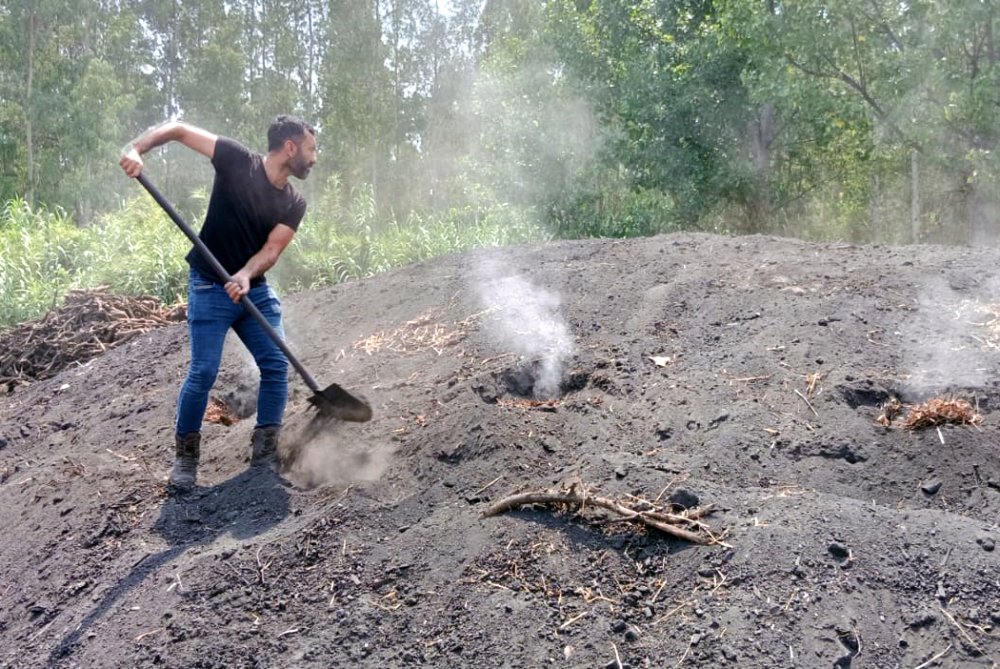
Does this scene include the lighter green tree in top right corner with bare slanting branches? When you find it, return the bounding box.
[720,0,1000,241]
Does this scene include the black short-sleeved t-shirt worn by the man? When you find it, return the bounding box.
[187,137,306,286]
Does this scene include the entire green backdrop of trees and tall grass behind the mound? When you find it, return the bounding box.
[0,0,1000,286]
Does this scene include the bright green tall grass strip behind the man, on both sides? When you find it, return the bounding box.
[0,179,545,326]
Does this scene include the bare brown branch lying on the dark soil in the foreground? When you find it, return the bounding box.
[483,485,720,545]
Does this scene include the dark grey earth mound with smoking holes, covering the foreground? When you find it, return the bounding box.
[0,235,1000,669]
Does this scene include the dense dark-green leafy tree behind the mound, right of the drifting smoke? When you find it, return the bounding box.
[548,0,767,230]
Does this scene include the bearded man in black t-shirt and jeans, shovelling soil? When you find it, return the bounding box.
[119,116,316,491]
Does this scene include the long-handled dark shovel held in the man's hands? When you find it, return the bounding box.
[136,174,372,423]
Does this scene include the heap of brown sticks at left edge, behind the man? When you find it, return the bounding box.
[0,287,184,392]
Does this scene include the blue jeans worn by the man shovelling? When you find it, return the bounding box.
[177,269,288,435]
